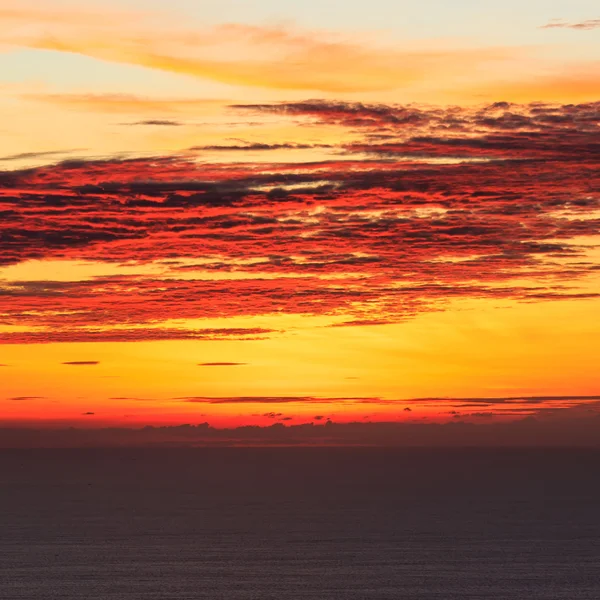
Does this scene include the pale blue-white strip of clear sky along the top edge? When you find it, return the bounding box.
[119,0,600,43]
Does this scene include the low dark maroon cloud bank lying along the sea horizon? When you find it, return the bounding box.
[0,414,600,448]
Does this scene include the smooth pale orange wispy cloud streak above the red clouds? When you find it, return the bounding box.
[0,5,576,93]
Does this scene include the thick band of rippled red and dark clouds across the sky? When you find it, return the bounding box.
[0,101,600,343]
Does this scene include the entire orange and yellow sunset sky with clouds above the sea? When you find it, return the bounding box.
[0,0,600,445]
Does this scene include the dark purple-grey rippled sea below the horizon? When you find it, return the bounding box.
[0,448,600,600]
